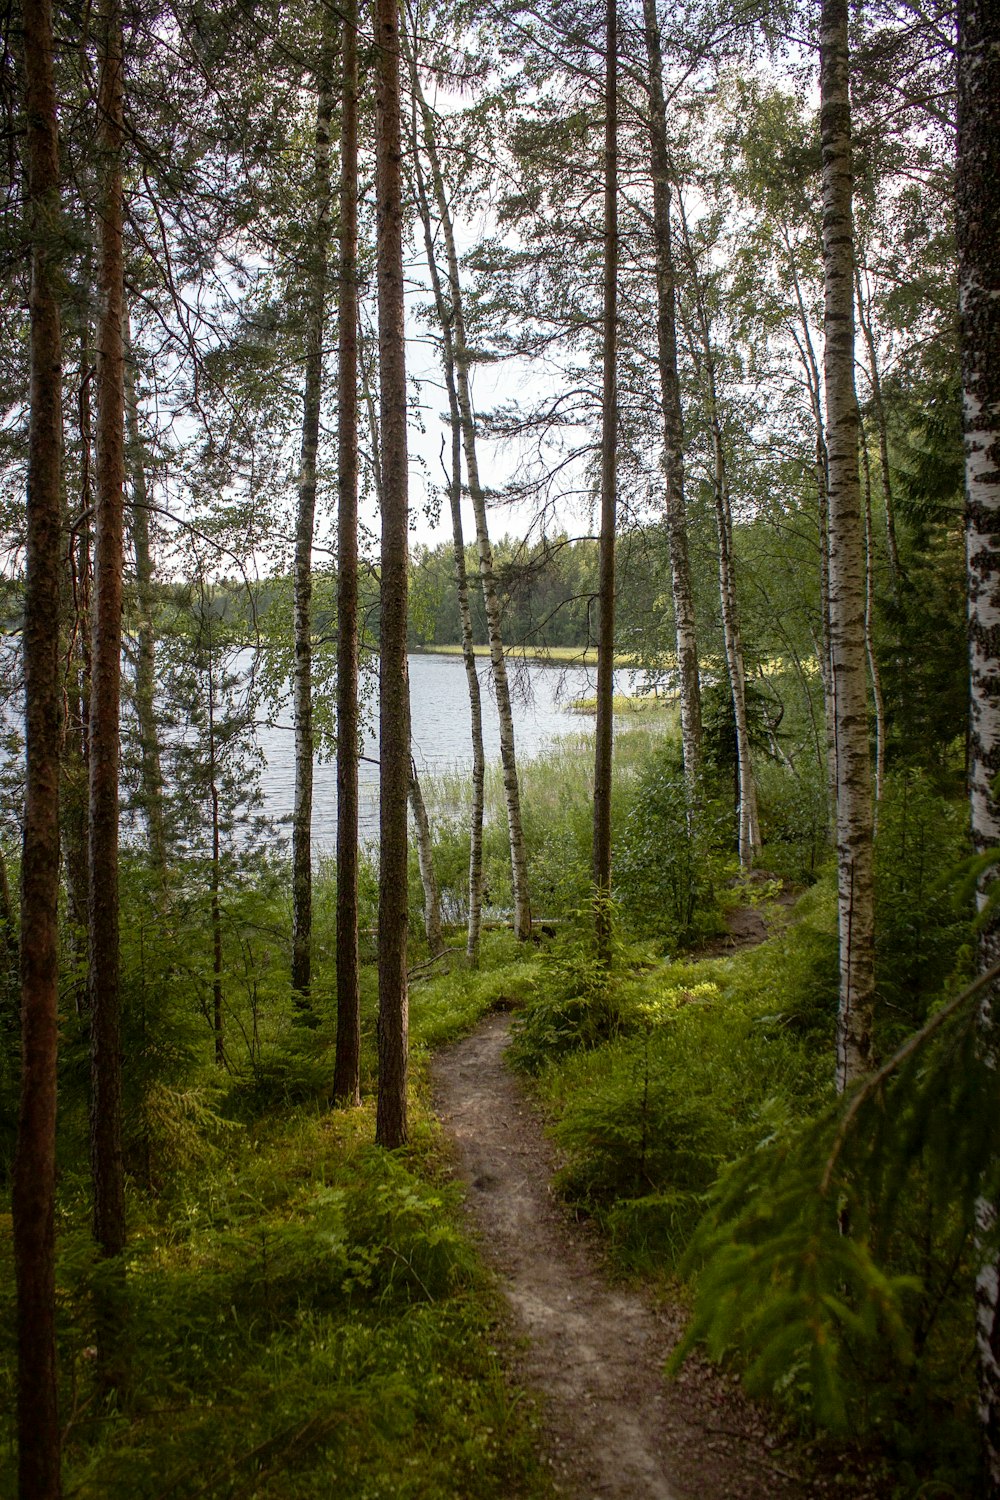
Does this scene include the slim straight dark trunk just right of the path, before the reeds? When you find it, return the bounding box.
[594,0,618,963]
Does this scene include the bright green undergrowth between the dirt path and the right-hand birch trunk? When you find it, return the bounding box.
[511,887,837,1275]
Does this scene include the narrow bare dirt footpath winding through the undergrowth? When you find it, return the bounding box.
[432,908,886,1500]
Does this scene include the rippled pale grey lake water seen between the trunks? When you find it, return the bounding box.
[259,653,634,855]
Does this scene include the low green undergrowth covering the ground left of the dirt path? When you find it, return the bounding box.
[0,945,547,1500]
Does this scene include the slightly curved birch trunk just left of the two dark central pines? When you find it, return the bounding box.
[292,3,333,1011]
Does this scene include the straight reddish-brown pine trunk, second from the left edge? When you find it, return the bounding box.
[88,0,124,1386]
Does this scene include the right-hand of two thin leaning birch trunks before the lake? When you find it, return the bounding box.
[411,57,531,941]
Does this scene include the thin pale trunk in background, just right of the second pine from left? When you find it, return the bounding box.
[124,315,166,885]
